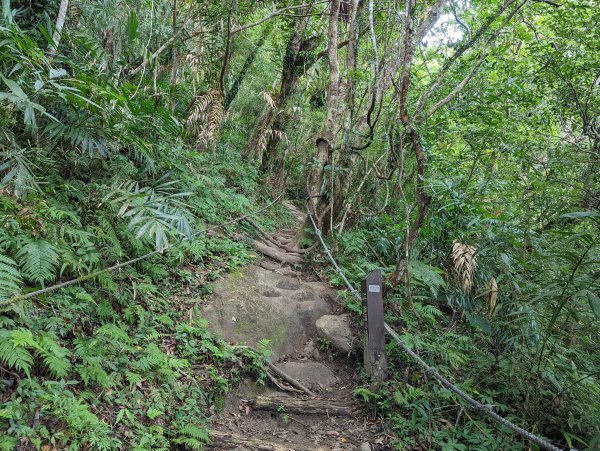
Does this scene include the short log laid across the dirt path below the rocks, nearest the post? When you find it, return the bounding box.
[250,396,358,417]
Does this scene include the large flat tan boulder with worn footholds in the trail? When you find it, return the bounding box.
[201,265,335,361]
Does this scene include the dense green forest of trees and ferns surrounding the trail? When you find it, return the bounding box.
[0,0,600,450]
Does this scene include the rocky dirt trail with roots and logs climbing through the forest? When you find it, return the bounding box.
[202,205,386,451]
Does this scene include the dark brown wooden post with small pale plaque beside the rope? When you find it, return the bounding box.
[362,269,388,382]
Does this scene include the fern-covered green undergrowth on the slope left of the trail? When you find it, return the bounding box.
[0,20,287,450]
